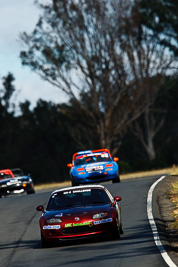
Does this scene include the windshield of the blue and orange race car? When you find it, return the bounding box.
[75,152,111,165]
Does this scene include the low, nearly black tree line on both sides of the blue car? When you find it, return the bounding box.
[0,74,178,183]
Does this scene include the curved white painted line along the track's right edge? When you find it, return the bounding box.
[147,176,177,267]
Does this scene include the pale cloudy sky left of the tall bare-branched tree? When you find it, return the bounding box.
[0,0,67,111]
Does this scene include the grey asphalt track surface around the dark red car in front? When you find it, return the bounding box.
[0,176,171,267]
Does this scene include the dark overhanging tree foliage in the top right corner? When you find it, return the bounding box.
[139,0,178,57]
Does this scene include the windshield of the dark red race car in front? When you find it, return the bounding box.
[47,189,110,210]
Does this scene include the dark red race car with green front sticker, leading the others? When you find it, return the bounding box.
[36,185,123,247]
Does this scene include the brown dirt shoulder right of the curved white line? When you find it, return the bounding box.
[155,175,178,265]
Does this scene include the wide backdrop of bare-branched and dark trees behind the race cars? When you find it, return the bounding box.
[0,0,178,184]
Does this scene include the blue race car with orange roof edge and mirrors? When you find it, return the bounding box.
[67,149,120,186]
